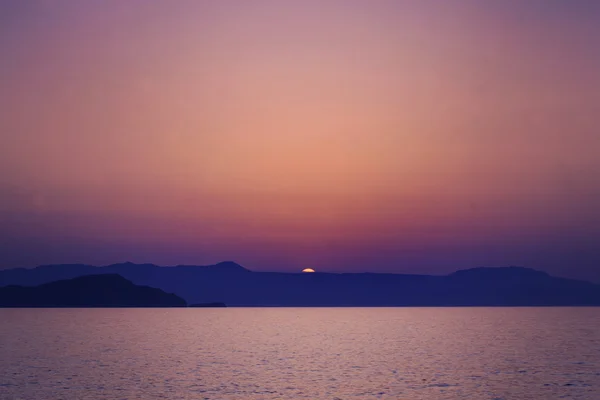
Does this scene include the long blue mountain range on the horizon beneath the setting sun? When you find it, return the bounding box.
[0,262,600,307]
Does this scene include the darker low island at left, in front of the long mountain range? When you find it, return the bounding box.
[0,274,187,307]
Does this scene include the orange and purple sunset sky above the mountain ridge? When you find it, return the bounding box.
[0,0,600,282]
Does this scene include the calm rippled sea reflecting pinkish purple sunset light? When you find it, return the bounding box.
[0,308,600,400]
